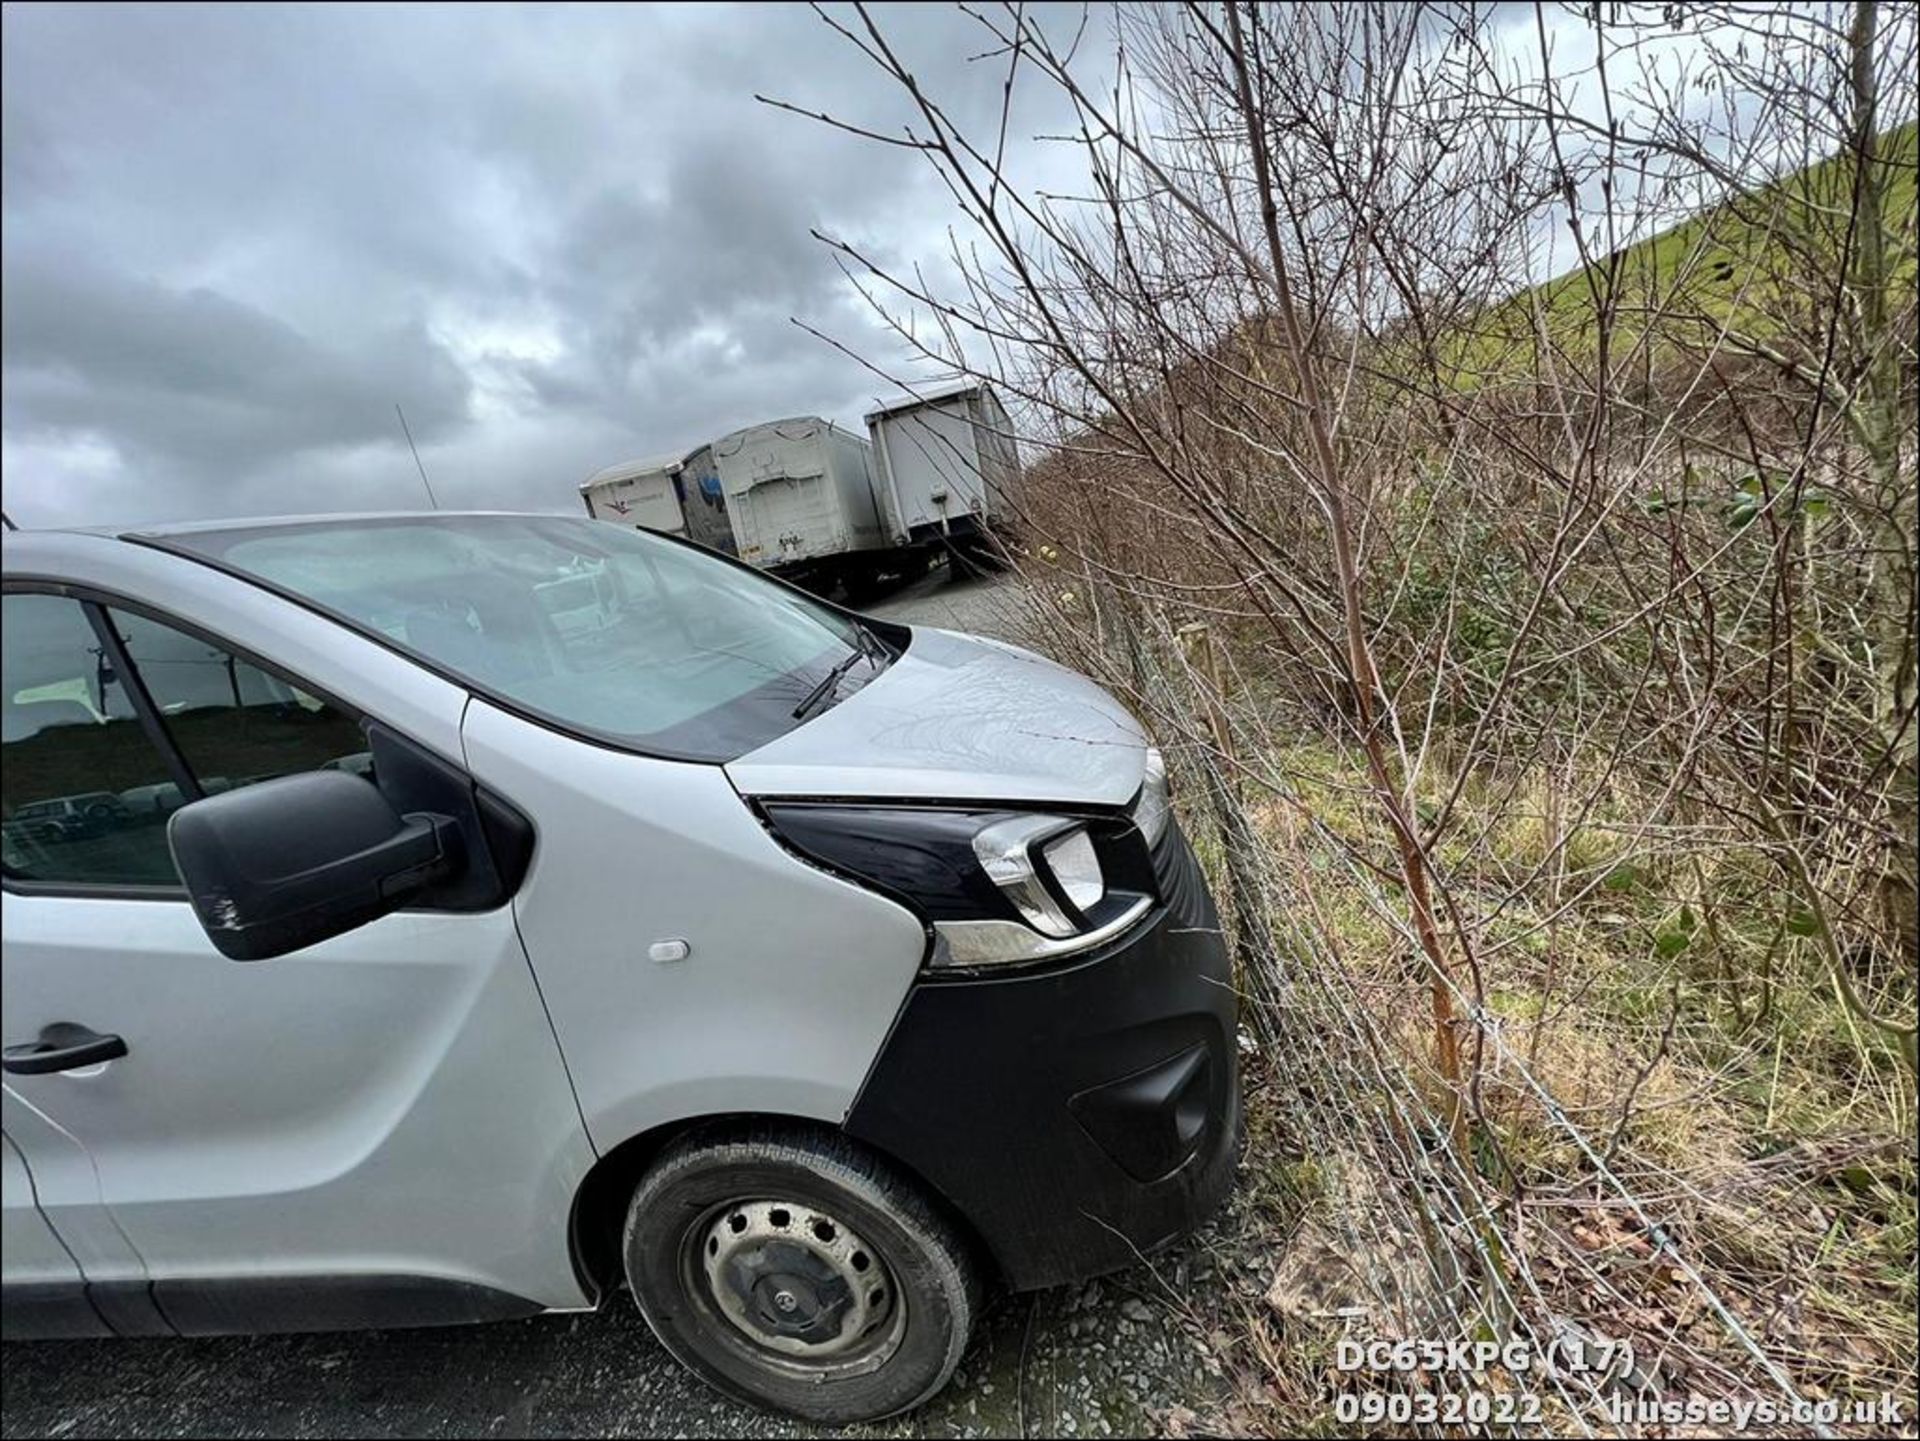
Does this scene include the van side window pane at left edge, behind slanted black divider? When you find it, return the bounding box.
[0,595,180,885]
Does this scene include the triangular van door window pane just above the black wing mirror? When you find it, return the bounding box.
[108,608,372,794]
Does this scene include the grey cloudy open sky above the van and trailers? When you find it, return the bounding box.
[0,4,1098,526]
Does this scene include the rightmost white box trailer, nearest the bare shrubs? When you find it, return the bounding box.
[866,382,1020,575]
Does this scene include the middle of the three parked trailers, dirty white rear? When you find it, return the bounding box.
[712,414,889,589]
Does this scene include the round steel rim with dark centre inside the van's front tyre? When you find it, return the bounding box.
[701,1201,897,1362]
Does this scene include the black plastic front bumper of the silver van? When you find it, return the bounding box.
[847,827,1240,1289]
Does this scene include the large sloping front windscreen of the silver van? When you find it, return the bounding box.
[153,514,889,762]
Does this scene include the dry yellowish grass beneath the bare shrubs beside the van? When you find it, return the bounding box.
[1037,598,1920,1435]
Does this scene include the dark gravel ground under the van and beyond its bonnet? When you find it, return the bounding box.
[0,570,1244,1437]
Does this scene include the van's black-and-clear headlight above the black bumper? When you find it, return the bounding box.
[764,804,1154,969]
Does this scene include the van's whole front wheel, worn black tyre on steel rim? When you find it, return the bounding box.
[624,1124,979,1424]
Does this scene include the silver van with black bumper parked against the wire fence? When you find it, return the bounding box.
[0,512,1240,1422]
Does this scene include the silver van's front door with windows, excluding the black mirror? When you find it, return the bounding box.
[0,591,591,1334]
